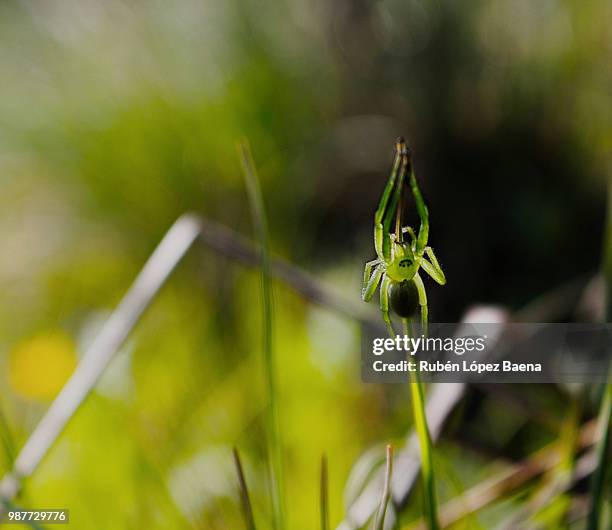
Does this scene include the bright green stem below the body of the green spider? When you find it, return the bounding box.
[402,318,440,530]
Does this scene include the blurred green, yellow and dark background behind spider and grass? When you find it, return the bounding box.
[0,0,612,530]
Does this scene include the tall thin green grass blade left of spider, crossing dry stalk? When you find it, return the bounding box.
[239,141,286,530]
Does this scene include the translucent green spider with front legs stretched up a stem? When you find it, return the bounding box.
[361,137,446,336]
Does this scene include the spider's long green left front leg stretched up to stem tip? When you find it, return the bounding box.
[374,139,408,259]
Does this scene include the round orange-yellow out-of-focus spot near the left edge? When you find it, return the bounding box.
[9,332,76,401]
